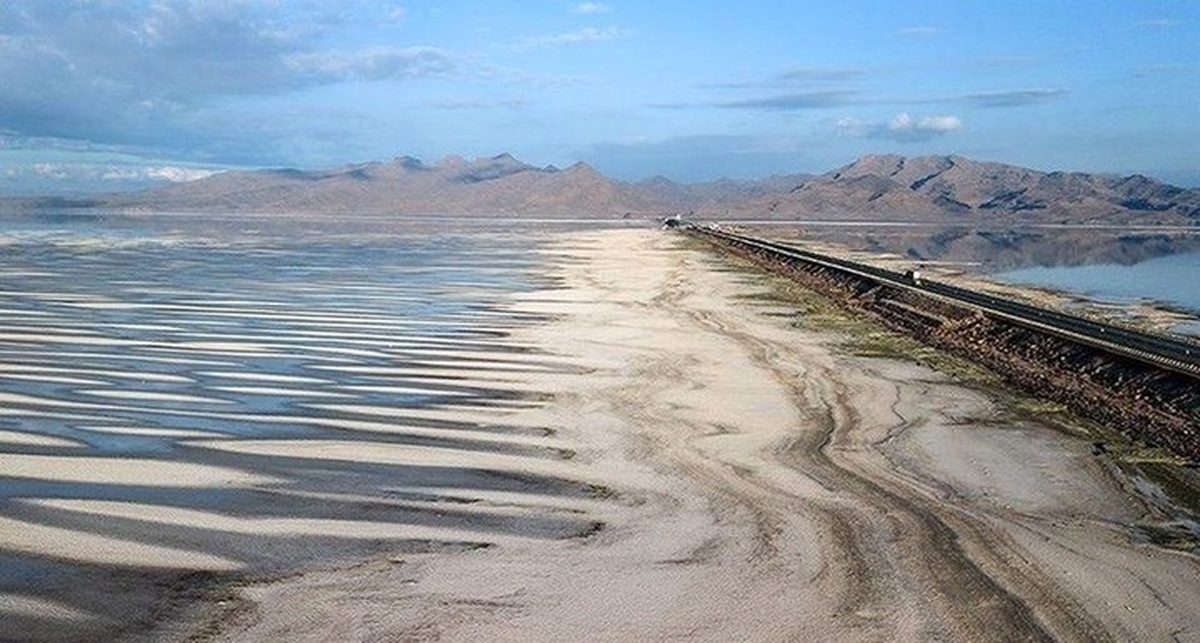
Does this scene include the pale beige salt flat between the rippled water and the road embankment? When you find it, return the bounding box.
[204,230,1200,641]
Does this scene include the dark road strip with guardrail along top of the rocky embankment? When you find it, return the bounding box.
[686,222,1200,379]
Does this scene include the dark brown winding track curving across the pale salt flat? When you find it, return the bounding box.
[654,238,1106,641]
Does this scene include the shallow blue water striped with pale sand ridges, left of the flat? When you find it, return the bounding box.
[0,216,604,638]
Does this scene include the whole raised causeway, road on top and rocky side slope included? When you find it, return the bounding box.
[678,223,1200,462]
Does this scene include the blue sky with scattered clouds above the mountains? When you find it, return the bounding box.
[0,0,1200,196]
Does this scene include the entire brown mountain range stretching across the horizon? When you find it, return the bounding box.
[8,154,1200,226]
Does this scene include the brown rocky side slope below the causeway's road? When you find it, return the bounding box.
[700,235,1200,463]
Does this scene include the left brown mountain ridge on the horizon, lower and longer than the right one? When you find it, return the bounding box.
[79,154,808,217]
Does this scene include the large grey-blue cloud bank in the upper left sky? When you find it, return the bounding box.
[0,0,456,162]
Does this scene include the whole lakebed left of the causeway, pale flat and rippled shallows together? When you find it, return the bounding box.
[0,223,1200,641]
